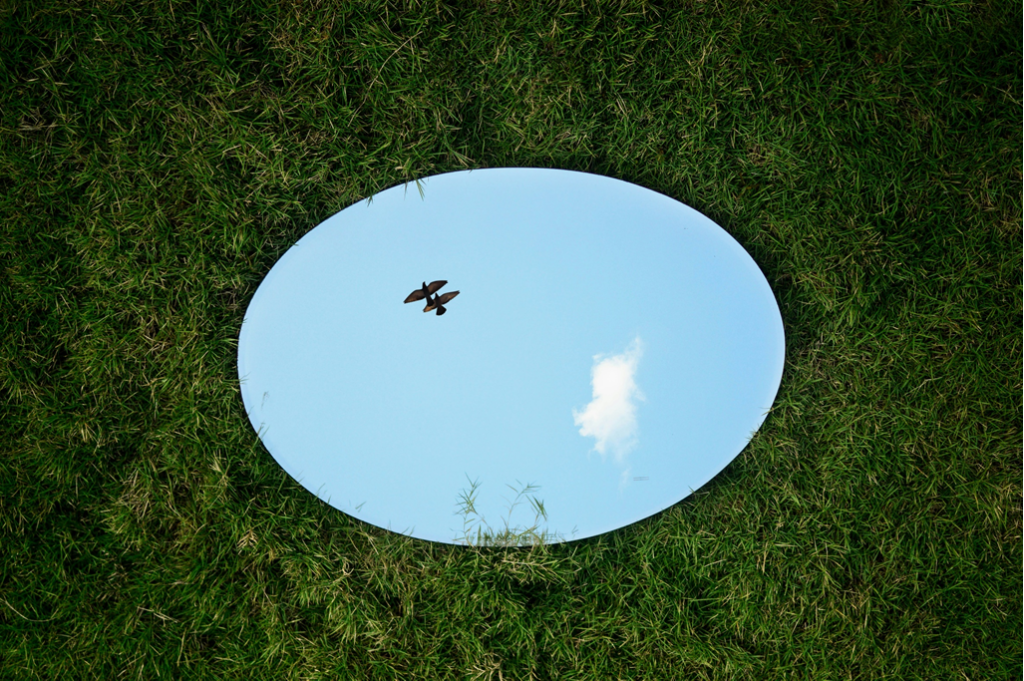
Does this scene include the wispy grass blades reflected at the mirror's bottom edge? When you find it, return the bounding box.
[454,476,562,546]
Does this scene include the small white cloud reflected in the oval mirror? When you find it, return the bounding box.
[572,336,644,463]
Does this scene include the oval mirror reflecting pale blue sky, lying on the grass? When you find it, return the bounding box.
[239,168,784,544]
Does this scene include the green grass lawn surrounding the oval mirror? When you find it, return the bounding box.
[0,0,1024,680]
